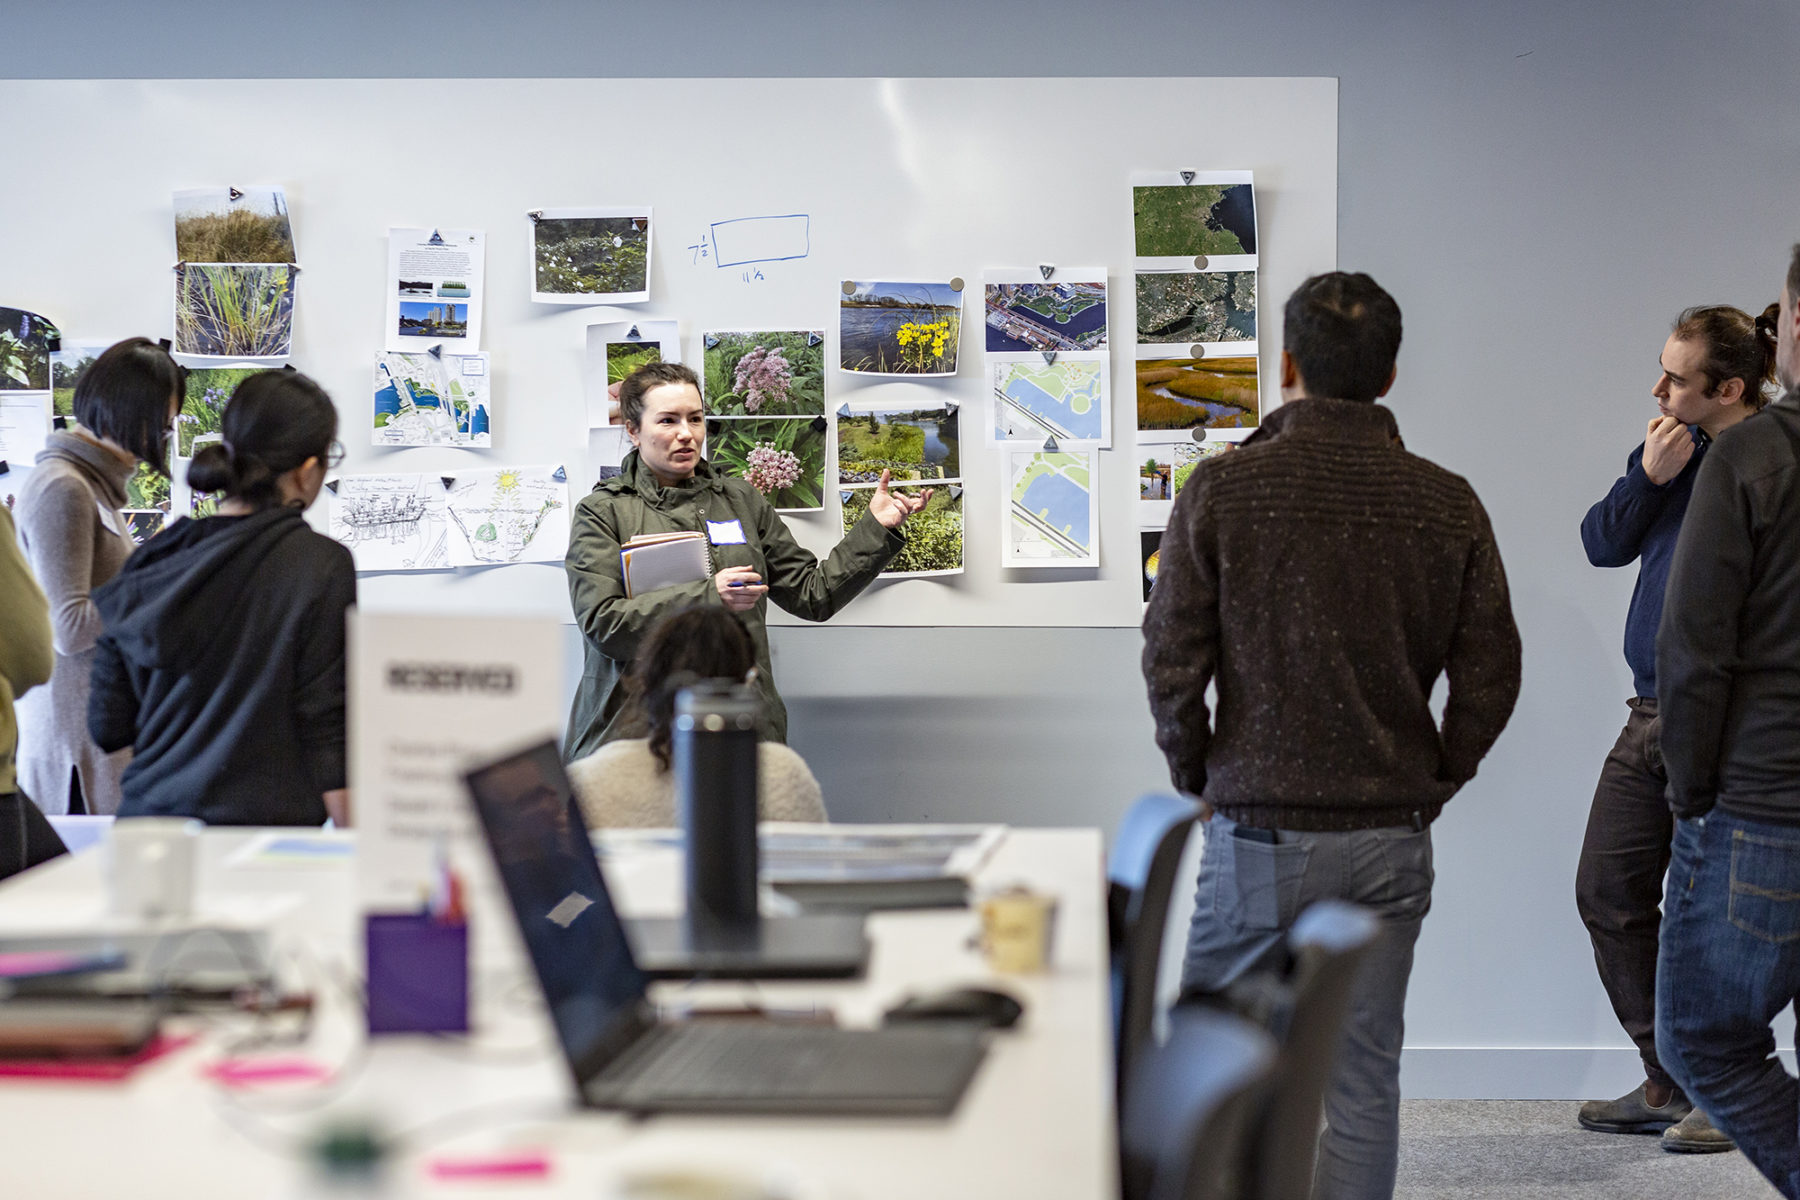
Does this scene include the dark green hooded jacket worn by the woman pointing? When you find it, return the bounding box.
[563,450,905,759]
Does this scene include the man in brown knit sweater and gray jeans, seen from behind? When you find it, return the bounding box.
[1143,272,1519,1200]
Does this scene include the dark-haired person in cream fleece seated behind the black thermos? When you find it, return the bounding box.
[569,604,824,826]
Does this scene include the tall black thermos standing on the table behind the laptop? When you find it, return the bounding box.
[675,680,761,932]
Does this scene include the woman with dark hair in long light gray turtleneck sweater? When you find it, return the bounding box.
[18,338,187,813]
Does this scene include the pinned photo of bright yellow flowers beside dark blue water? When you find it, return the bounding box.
[837,281,963,374]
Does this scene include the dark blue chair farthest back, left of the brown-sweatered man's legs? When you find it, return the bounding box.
[1107,793,1201,1097]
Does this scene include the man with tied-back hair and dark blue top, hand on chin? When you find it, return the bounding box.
[1575,304,1775,1153]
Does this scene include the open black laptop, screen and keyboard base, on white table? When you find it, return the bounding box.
[464,741,986,1115]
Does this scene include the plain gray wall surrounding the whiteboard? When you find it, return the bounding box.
[14,0,1800,1094]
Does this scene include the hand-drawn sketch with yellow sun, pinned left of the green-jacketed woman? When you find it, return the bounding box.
[446,466,569,567]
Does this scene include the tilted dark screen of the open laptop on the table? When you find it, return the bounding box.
[464,741,646,1085]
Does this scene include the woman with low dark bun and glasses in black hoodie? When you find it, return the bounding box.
[88,371,356,826]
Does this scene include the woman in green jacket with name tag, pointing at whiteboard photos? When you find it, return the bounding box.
[563,363,931,759]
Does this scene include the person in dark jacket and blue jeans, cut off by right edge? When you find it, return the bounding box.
[1656,245,1800,1200]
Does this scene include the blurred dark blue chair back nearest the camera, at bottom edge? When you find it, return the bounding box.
[1120,1007,1280,1200]
